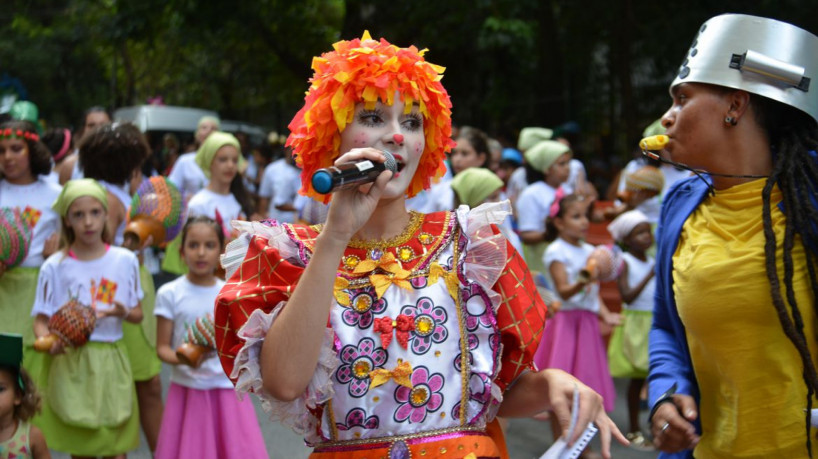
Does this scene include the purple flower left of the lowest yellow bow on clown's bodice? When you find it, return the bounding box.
[335,338,389,398]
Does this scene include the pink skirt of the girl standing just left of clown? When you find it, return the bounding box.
[154,383,270,459]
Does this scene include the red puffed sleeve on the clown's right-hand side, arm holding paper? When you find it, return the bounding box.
[494,237,547,391]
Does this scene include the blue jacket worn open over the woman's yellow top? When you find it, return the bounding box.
[648,177,708,459]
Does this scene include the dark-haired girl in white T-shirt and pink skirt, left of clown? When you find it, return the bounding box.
[154,217,269,459]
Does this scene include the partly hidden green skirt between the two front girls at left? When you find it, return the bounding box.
[122,266,162,381]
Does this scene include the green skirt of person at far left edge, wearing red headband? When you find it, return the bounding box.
[0,267,40,346]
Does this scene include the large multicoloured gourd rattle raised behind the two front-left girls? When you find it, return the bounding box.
[125,176,187,247]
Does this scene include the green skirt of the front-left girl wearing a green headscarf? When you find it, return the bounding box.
[33,341,139,456]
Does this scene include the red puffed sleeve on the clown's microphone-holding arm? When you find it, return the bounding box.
[214,236,304,383]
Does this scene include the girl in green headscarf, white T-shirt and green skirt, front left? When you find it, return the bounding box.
[32,179,142,457]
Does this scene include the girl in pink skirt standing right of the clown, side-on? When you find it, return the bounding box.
[534,194,622,456]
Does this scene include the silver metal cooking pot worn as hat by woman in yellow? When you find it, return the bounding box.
[670,14,818,121]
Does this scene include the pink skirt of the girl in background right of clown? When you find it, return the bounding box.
[534,310,616,412]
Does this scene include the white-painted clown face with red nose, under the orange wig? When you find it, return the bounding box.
[340,94,426,199]
